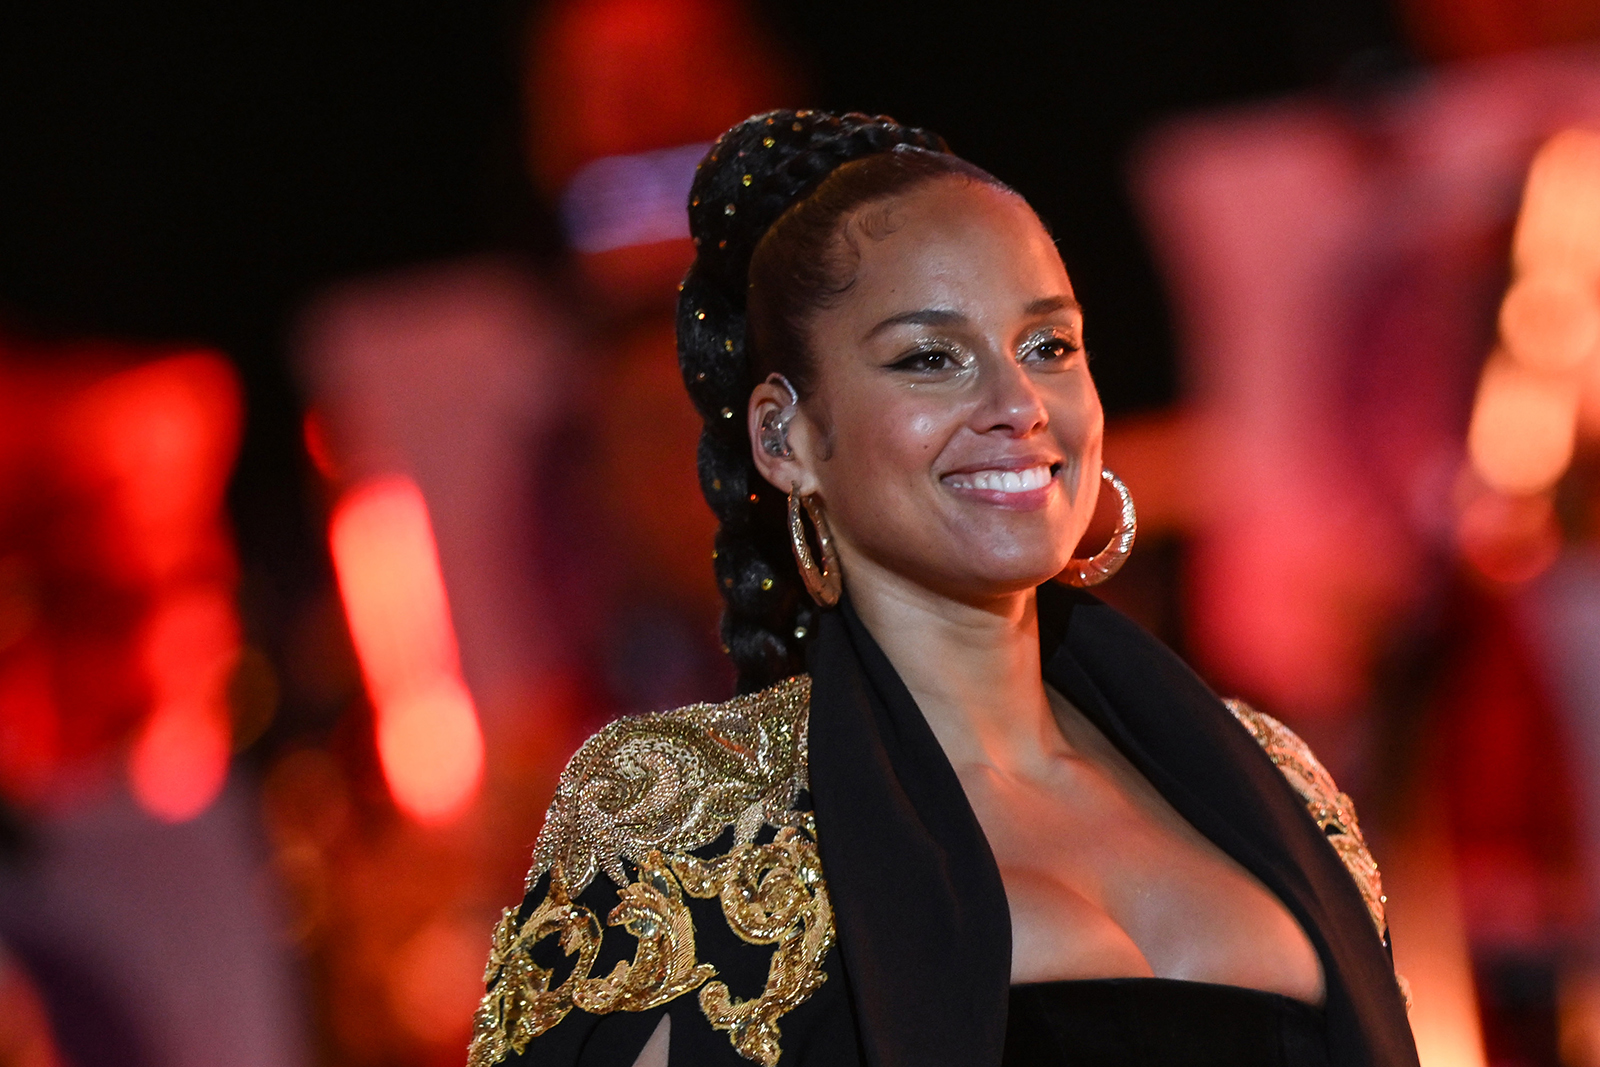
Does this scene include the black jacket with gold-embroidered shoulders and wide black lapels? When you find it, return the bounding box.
[470,584,1418,1067]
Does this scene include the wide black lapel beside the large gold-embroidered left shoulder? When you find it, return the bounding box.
[806,600,1011,1067]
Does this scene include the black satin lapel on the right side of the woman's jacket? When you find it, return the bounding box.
[1038,584,1418,1067]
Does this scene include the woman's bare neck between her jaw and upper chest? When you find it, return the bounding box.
[846,560,1066,771]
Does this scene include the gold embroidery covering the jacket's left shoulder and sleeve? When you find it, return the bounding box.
[467,675,834,1067]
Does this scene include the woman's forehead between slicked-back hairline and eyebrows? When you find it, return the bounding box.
[835,176,1072,327]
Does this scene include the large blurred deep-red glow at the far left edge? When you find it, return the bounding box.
[0,338,243,821]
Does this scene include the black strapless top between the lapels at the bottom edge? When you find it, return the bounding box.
[1002,977,1328,1067]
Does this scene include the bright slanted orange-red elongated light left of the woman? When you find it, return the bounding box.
[330,475,483,822]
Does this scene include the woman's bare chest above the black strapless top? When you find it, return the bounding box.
[962,745,1322,1001]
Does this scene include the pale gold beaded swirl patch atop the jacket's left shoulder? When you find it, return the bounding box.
[528,675,811,894]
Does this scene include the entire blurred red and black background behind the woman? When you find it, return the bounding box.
[0,0,1600,1067]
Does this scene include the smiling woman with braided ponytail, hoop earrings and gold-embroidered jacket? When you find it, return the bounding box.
[472,112,1416,1067]
